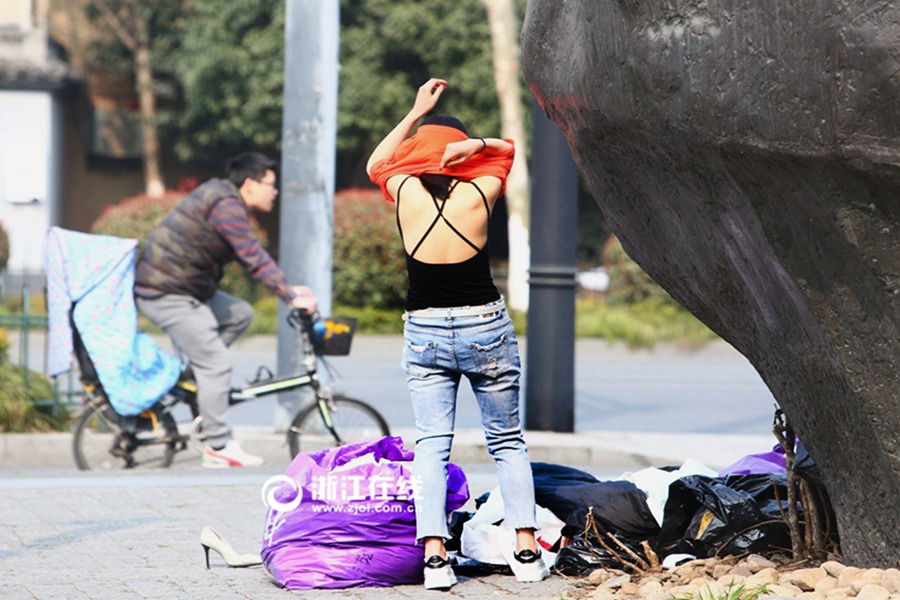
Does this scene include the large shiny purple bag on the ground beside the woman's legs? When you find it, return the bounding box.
[262,437,469,589]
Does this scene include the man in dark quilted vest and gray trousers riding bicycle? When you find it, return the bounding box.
[134,152,317,468]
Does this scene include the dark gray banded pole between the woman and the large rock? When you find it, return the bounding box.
[525,101,578,432]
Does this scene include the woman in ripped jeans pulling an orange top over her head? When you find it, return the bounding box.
[366,79,549,589]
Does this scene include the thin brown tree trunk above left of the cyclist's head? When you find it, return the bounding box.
[134,11,166,198]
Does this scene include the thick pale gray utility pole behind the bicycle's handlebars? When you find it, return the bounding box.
[275,0,340,431]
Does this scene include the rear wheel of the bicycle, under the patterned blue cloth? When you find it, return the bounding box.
[72,398,180,471]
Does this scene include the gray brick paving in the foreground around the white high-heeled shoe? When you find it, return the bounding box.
[0,467,581,600]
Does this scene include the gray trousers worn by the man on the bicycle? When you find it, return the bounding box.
[135,292,253,444]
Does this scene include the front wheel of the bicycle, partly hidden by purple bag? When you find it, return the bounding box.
[288,394,391,458]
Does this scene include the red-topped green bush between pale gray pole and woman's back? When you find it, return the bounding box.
[332,188,407,309]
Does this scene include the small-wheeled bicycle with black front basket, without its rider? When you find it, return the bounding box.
[72,309,390,470]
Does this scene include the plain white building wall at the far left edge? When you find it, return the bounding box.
[0,90,61,273]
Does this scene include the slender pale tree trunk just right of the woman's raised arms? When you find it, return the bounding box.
[482,0,531,312]
